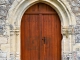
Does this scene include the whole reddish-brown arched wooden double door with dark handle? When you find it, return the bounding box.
[21,3,62,60]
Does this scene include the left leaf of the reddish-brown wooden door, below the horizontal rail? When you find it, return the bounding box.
[22,15,40,60]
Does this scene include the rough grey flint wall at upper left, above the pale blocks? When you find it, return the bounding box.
[0,0,14,35]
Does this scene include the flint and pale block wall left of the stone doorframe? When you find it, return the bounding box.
[0,0,14,60]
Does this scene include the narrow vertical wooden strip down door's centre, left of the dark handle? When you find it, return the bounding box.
[39,14,45,60]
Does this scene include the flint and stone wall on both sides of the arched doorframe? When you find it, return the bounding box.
[0,0,80,60]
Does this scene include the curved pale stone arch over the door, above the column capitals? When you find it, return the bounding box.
[7,0,76,28]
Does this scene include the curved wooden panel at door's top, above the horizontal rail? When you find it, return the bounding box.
[24,2,57,14]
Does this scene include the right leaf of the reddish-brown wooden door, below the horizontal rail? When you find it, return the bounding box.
[42,15,61,60]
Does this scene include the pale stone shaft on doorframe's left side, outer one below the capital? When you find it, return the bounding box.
[10,30,16,60]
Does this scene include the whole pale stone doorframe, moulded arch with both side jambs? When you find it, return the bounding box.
[6,0,76,60]
